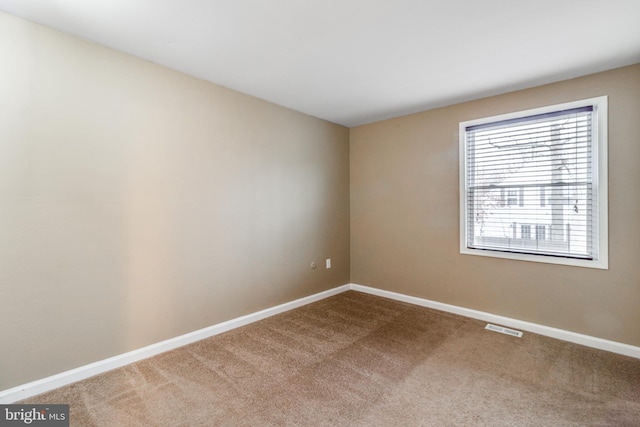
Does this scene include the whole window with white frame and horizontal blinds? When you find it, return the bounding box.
[460,97,608,269]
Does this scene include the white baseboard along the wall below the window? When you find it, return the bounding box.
[349,283,640,359]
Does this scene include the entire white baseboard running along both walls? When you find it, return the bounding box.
[0,283,640,404]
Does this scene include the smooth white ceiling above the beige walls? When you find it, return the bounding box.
[0,0,640,126]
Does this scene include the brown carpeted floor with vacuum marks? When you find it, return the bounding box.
[24,291,640,426]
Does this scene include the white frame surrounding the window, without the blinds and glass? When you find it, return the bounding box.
[459,96,609,269]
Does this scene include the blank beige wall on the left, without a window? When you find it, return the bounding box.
[0,13,349,390]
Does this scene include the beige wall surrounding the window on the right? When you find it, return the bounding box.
[350,65,640,346]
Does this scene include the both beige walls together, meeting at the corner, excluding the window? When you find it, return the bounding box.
[0,7,640,390]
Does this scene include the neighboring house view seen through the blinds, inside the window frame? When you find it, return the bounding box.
[468,108,595,257]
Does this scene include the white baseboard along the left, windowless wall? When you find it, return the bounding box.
[0,284,350,404]
